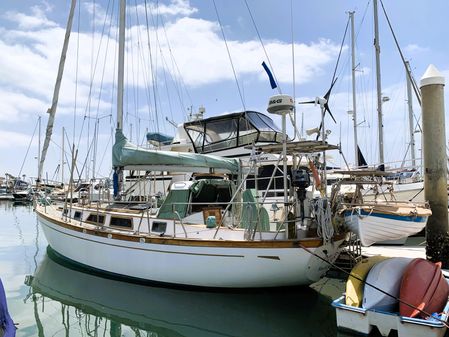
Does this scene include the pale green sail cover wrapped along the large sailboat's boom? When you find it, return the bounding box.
[112,130,240,173]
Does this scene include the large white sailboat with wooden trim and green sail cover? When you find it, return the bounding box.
[36,0,346,288]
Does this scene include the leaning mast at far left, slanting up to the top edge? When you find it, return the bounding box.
[37,0,76,181]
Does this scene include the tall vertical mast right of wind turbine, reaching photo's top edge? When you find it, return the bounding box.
[373,0,385,165]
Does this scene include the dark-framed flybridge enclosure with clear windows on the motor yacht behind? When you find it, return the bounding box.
[184,111,282,153]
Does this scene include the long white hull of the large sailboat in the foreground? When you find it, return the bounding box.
[37,210,343,288]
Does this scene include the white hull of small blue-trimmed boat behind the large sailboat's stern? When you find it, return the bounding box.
[345,212,427,247]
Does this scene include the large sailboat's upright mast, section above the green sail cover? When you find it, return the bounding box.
[117,0,126,131]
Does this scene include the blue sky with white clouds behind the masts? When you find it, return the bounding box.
[0,0,449,184]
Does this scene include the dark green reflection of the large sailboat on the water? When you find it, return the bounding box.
[25,248,337,337]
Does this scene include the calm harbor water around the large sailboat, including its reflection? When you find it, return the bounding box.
[0,202,380,337]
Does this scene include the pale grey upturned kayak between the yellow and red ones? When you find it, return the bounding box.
[362,257,413,312]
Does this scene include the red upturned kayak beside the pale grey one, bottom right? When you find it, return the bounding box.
[399,259,449,318]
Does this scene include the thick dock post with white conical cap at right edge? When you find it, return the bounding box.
[420,65,449,268]
